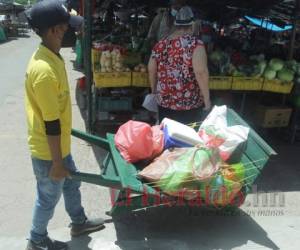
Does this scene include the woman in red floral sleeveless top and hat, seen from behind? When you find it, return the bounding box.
[148,6,211,124]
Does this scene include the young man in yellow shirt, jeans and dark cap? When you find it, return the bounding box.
[25,0,104,250]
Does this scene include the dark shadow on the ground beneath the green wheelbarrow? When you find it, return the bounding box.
[113,207,279,250]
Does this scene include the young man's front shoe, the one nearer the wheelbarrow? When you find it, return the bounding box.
[71,219,105,237]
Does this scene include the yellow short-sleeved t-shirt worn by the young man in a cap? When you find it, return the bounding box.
[25,45,72,160]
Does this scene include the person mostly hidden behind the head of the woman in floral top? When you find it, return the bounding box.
[147,0,186,49]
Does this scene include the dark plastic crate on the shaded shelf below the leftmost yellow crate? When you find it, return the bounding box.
[97,96,132,112]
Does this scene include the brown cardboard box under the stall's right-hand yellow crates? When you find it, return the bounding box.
[255,105,292,128]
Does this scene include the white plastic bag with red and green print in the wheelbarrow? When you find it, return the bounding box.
[198,106,249,161]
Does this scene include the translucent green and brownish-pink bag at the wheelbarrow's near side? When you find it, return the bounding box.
[139,147,221,199]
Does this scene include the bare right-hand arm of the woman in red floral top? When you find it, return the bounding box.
[193,46,211,110]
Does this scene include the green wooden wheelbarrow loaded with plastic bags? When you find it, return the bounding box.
[72,109,276,216]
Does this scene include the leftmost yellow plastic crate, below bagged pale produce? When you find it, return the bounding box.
[94,72,131,88]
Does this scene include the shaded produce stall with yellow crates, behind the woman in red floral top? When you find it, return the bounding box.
[82,1,300,141]
